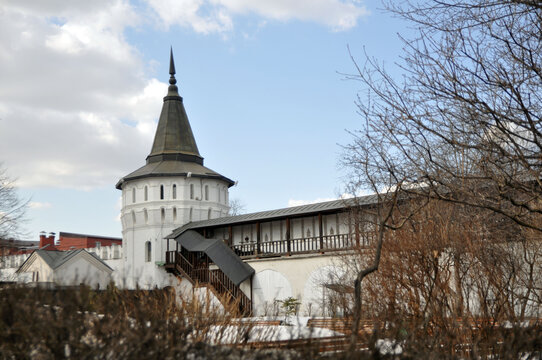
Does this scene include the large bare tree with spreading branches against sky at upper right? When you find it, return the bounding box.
[346,0,542,230]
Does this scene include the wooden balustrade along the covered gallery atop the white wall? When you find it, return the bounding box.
[231,234,356,257]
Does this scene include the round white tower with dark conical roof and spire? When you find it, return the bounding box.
[116,52,234,288]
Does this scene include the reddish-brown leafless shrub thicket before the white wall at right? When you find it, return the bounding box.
[345,201,542,358]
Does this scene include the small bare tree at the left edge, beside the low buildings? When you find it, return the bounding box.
[0,165,28,239]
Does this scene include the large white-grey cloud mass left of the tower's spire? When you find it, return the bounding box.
[0,0,159,190]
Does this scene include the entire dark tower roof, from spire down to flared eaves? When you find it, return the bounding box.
[116,51,234,189]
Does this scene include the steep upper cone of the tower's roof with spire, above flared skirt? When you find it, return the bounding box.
[147,51,203,162]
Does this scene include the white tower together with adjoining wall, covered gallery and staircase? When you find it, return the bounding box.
[116,50,375,315]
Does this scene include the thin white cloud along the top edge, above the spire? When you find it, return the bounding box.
[146,0,368,34]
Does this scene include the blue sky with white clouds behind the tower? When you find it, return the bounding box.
[0,0,406,240]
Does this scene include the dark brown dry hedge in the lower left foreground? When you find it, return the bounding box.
[0,286,302,359]
